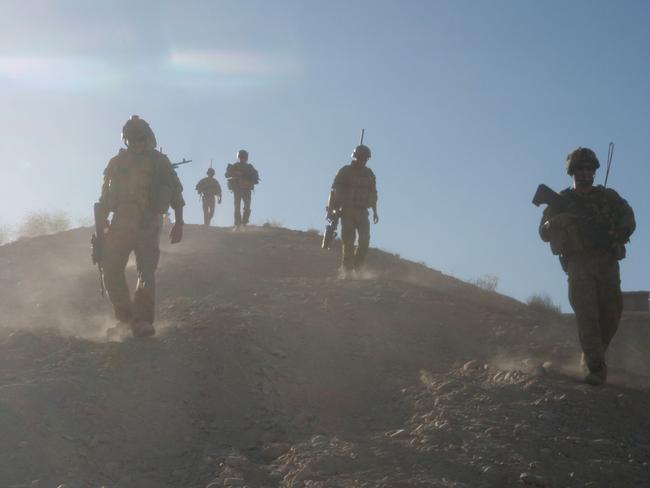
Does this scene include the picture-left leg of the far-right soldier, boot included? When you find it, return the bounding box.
[569,263,605,372]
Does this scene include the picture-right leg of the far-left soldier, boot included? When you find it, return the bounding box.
[133,226,160,335]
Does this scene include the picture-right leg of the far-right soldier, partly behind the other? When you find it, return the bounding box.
[598,261,623,351]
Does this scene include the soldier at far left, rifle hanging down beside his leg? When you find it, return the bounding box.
[95,115,185,337]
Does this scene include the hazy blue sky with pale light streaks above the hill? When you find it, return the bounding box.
[0,0,650,309]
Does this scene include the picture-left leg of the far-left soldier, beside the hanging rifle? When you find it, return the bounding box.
[102,228,133,323]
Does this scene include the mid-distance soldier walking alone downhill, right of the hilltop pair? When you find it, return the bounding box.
[327,145,379,276]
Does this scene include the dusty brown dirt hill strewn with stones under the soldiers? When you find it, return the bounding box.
[0,226,650,488]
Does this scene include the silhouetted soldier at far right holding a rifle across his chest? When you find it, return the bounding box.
[539,147,636,385]
